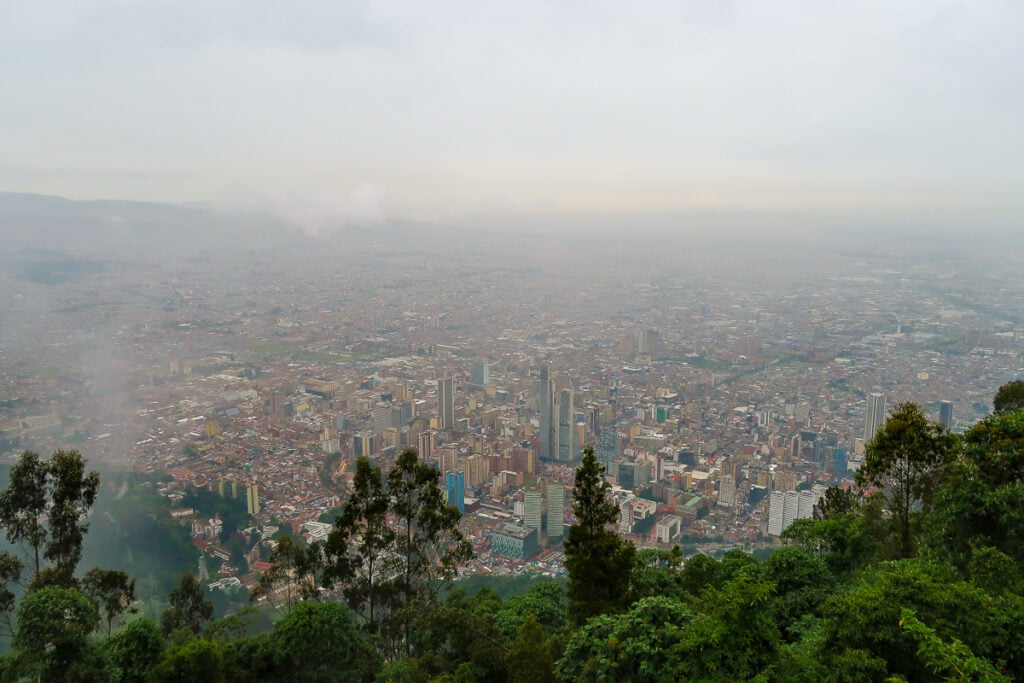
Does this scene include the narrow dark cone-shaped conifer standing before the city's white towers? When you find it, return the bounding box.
[565,445,635,625]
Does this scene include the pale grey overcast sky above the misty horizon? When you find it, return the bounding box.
[0,0,1024,231]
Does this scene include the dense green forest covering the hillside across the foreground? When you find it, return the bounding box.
[0,382,1024,682]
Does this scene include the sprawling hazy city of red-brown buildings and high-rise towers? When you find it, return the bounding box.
[0,215,1024,588]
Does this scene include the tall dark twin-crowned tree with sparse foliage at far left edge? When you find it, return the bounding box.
[0,451,99,585]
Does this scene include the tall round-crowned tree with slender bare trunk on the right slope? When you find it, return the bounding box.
[857,402,955,558]
